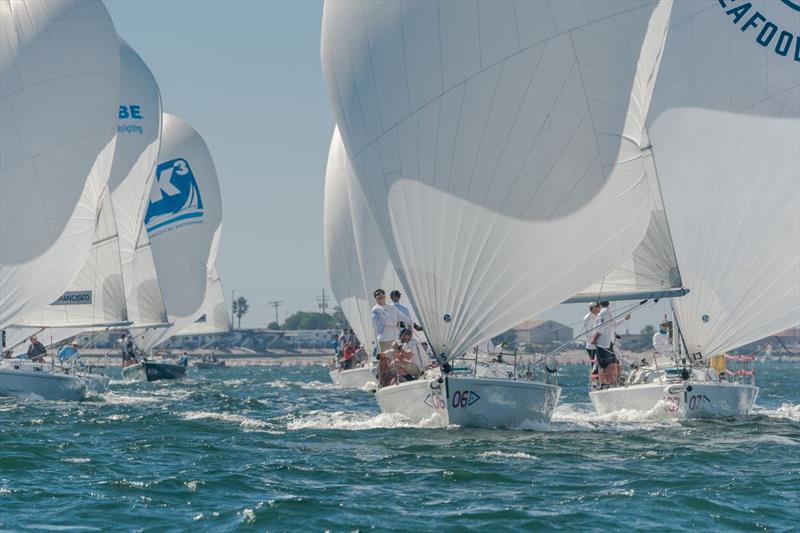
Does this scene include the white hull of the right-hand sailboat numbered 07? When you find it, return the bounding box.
[589,383,758,420]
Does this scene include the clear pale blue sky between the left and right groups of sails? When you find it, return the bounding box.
[106,0,668,333]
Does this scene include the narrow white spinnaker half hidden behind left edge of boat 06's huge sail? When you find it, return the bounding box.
[324,129,375,347]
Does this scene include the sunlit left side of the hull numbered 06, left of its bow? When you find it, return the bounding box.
[375,378,448,427]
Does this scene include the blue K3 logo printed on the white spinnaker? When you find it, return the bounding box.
[144,157,203,233]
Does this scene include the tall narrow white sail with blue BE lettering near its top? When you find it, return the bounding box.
[109,40,166,325]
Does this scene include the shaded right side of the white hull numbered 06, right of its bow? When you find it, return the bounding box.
[447,376,561,428]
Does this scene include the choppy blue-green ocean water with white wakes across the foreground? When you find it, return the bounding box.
[0,363,800,531]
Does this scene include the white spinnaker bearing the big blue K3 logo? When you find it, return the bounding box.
[136,113,222,350]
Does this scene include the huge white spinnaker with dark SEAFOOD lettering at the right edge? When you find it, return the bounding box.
[647,0,800,357]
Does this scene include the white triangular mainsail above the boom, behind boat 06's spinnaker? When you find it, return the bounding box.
[565,151,687,303]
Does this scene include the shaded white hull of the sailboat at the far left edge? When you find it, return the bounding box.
[0,363,87,401]
